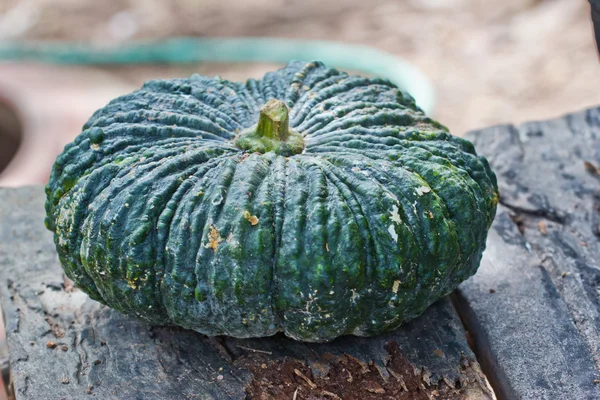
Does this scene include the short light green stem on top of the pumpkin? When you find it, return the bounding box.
[235,99,304,157]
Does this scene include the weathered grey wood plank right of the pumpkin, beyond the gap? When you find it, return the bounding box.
[459,108,600,399]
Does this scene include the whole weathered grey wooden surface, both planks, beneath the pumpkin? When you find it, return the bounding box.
[0,104,600,400]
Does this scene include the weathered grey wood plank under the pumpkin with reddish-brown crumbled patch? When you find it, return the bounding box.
[0,187,493,400]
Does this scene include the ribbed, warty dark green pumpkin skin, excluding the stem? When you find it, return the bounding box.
[46,62,498,342]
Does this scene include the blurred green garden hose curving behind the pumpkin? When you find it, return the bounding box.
[0,38,435,115]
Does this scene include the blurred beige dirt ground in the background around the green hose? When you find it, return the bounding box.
[0,0,600,135]
